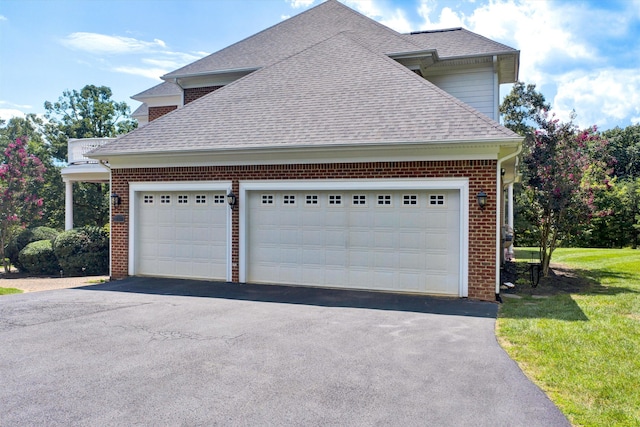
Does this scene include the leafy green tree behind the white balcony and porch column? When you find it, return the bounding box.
[44,85,137,227]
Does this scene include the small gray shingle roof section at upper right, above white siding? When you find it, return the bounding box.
[406,28,518,59]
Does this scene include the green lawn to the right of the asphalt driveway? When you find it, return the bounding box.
[497,249,640,426]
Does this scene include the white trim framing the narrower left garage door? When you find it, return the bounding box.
[128,181,232,282]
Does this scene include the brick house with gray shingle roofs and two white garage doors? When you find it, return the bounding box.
[88,0,522,300]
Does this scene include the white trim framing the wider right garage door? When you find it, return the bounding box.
[239,178,469,297]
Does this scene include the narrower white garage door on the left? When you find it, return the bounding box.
[134,191,229,280]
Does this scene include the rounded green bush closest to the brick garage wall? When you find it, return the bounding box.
[53,226,109,276]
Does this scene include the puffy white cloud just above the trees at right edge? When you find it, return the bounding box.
[552,68,640,128]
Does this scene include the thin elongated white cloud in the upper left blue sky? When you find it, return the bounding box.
[61,32,167,55]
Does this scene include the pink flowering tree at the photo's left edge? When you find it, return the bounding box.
[0,138,46,272]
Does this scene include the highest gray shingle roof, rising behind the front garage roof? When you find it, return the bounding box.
[163,0,420,79]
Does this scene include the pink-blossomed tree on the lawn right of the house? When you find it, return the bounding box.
[522,112,611,276]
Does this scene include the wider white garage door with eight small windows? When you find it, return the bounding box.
[246,189,461,295]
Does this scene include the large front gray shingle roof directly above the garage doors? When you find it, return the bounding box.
[91,33,517,157]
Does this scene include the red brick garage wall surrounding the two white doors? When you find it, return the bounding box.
[111,160,497,301]
